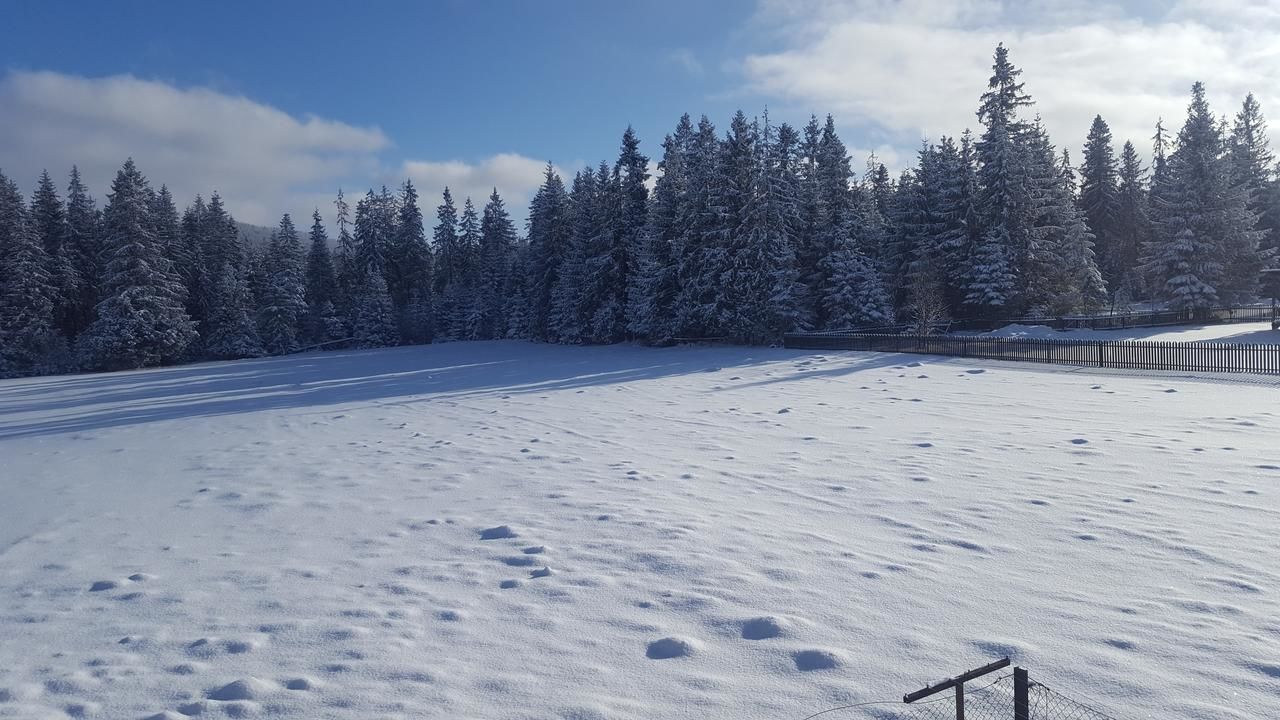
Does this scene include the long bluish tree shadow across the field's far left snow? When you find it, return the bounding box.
[0,341,797,438]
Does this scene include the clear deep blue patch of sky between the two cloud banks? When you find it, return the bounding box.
[3,0,750,160]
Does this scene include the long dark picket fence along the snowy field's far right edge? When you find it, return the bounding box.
[783,333,1280,374]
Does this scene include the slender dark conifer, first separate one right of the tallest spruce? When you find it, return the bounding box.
[1079,115,1129,287]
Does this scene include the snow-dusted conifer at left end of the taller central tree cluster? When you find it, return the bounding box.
[525,163,572,341]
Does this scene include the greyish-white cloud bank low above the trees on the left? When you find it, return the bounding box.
[0,72,560,225]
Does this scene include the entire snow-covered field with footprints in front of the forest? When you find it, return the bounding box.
[0,342,1280,720]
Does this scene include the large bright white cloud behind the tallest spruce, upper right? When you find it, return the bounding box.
[741,0,1280,170]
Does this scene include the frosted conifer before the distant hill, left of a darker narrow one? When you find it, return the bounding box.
[257,213,307,355]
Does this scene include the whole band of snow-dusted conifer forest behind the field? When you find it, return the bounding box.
[0,46,1280,377]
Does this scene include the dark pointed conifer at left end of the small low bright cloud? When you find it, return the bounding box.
[387,181,434,343]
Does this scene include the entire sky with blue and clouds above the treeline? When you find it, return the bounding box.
[0,0,1280,223]
